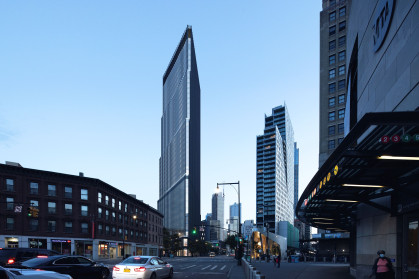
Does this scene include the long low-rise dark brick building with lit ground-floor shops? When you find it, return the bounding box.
[0,162,163,259]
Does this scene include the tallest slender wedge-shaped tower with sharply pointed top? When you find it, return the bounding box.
[158,26,201,244]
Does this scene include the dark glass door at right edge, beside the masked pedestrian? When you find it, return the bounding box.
[404,219,419,279]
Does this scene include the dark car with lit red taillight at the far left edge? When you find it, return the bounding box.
[0,248,59,267]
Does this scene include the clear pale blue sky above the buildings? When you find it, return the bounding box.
[0,0,321,225]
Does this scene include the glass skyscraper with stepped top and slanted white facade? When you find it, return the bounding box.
[256,106,294,234]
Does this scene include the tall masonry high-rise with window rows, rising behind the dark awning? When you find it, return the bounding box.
[319,0,351,167]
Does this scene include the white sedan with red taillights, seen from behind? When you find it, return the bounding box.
[112,256,173,279]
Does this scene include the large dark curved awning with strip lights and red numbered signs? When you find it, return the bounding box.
[296,111,419,231]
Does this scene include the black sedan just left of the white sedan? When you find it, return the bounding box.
[20,255,110,279]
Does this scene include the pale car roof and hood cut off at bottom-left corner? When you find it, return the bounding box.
[0,267,73,279]
